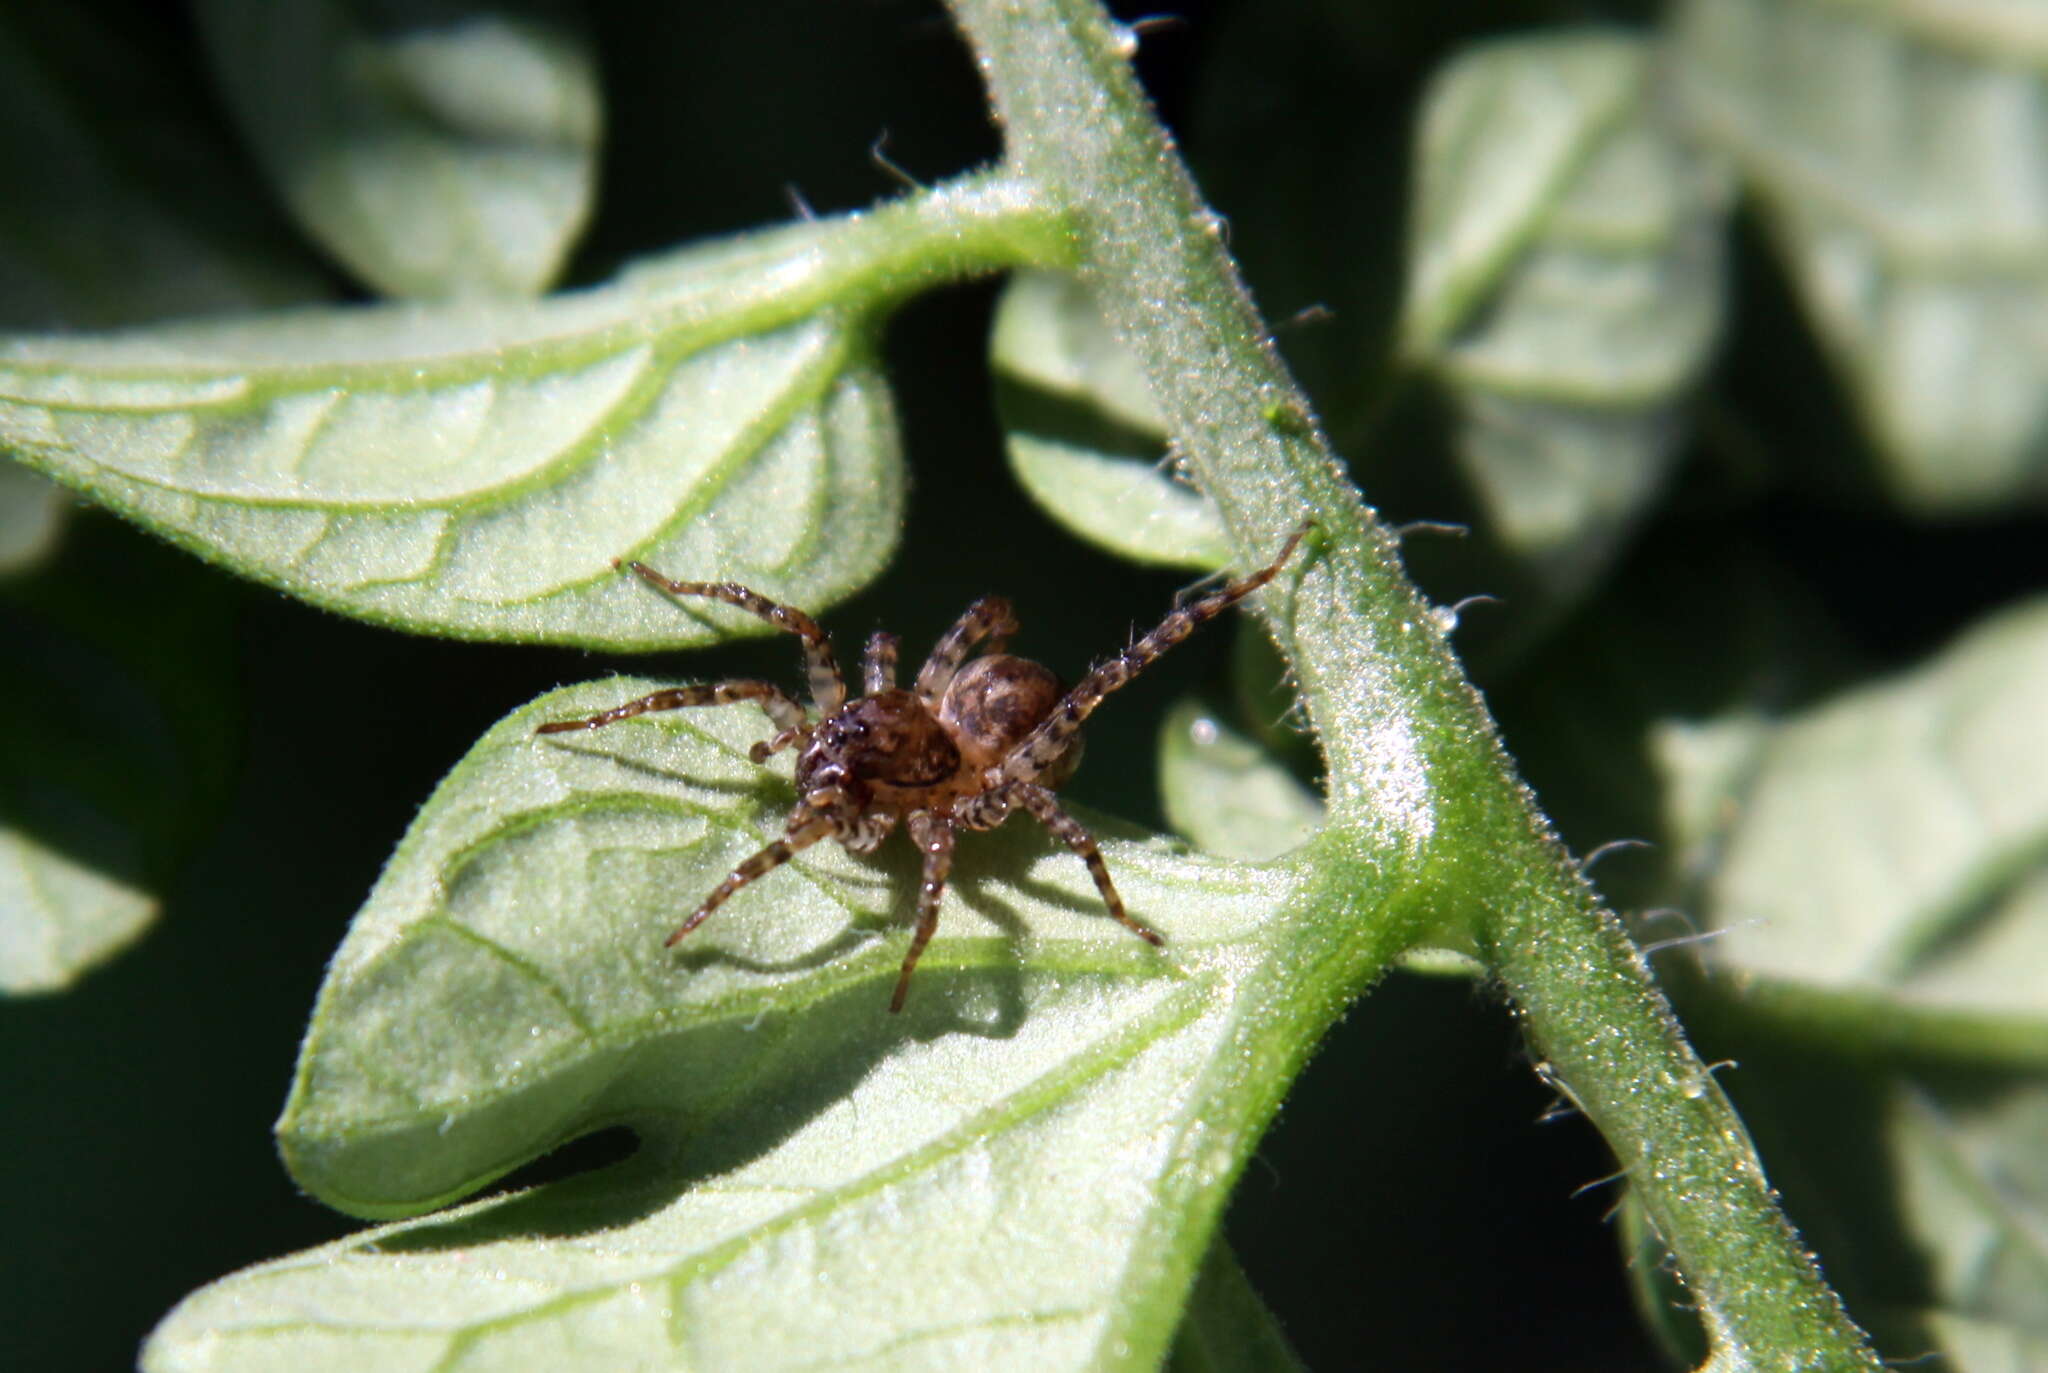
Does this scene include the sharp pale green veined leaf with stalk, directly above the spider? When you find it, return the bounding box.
[0,180,1055,650]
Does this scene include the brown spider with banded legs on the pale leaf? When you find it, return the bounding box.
[537,525,1309,1012]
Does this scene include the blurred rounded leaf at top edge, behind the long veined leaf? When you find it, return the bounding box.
[199,0,602,299]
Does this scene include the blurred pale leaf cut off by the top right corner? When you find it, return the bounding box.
[1671,0,2048,514]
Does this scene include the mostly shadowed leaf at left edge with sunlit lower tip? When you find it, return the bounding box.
[0,521,236,992]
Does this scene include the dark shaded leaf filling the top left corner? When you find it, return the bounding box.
[0,4,326,328]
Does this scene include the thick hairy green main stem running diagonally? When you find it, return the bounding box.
[950,0,1878,1367]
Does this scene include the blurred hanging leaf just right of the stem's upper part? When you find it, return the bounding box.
[1403,31,1726,598]
